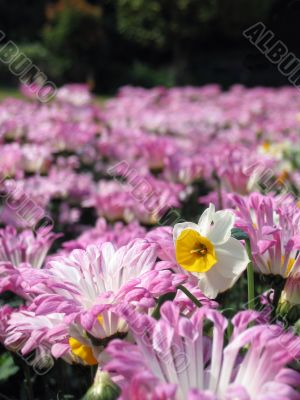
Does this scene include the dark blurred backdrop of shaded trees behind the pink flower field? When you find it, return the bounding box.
[0,0,300,94]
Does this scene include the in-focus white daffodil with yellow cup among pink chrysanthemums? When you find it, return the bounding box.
[173,204,249,298]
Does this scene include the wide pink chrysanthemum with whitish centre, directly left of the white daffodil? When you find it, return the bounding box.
[16,240,185,360]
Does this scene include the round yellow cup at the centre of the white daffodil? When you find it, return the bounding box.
[175,229,218,272]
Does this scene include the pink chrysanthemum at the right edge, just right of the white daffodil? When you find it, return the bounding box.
[232,193,300,278]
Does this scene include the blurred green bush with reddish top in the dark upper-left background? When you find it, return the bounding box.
[43,0,104,82]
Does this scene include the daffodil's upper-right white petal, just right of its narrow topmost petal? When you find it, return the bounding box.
[207,211,235,245]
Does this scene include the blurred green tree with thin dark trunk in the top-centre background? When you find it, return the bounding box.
[111,0,217,83]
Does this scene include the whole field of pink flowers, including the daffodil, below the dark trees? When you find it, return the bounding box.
[0,84,300,400]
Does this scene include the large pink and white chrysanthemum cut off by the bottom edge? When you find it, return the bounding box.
[106,302,300,400]
